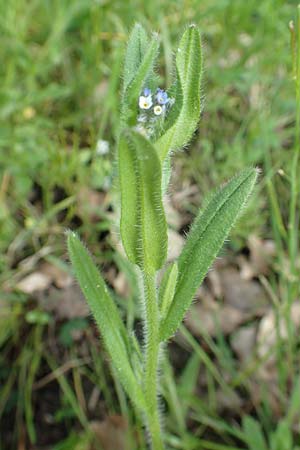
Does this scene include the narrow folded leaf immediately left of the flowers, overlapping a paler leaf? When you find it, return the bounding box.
[121,34,159,125]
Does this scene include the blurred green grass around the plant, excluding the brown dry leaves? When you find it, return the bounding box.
[0,0,300,450]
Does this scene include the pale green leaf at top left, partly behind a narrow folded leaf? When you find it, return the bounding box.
[123,23,148,91]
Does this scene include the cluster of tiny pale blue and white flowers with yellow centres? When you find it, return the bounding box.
[137,87,174,137]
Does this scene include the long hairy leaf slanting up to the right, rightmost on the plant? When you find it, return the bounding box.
[160,169,257,340]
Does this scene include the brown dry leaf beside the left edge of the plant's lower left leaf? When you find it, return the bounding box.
[37,285,89,320]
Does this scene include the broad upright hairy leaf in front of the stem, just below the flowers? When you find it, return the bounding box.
[118,130,168,272]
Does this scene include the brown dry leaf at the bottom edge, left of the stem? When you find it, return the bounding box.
[90,415,128,450]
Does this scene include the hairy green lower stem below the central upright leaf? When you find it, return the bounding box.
[143,273,164,450]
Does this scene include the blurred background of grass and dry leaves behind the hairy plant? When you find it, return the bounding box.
[0,0,300,450]
